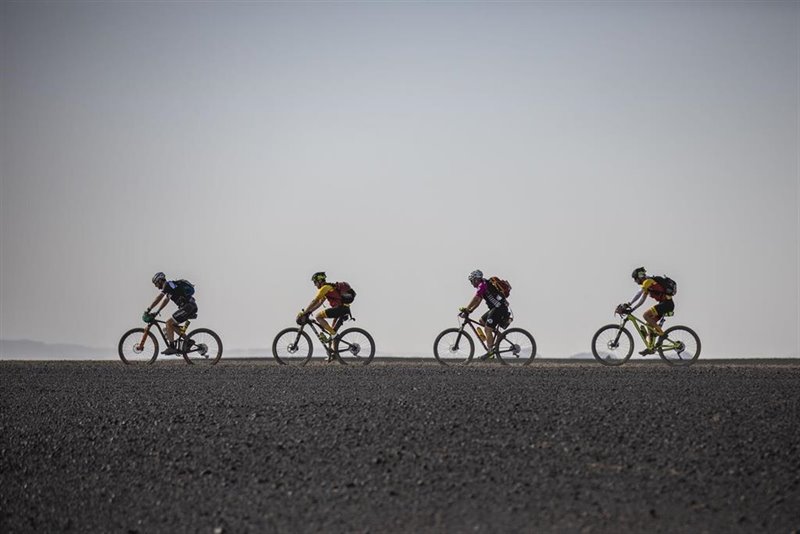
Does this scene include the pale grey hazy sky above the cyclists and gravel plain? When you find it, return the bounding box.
[0,1,800,357]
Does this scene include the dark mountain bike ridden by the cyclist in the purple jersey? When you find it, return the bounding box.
[433,313,536,366]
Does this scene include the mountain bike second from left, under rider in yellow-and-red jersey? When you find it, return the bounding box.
[272,313,375,366]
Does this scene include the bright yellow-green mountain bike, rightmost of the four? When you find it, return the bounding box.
[592,311,700,367]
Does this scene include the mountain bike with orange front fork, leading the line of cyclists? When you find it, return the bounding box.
[117,315,222,365]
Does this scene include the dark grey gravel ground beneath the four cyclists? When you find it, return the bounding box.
[0,360,800,534]
